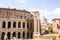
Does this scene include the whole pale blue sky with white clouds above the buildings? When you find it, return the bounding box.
[0,0,60,22]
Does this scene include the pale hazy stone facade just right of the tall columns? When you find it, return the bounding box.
[40,17,48,34]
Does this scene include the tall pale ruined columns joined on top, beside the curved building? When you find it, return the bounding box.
[33,11,40,40]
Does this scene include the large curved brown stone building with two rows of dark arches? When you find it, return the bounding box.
[0,8,34,40]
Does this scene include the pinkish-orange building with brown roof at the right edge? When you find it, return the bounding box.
[52,18,60,34]
